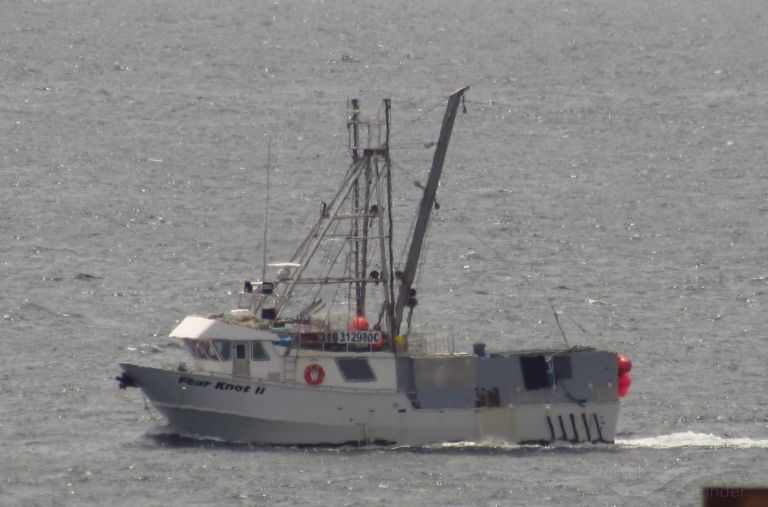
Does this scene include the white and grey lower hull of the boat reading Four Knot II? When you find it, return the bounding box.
[121,364,619,445]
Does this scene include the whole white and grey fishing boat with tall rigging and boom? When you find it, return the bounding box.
[117,87,631,445]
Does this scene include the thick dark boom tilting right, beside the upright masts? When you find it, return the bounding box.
[392,86,469,335]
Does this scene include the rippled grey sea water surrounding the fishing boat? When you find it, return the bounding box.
[0,0,768,506]
